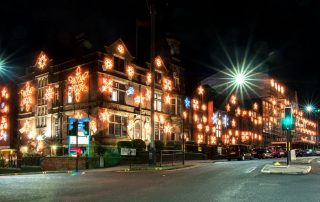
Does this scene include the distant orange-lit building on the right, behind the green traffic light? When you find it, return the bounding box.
[202,73,318,147]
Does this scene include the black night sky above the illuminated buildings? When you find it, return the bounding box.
[0,0,320,104]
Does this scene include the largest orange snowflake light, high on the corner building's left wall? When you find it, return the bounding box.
[68,66,89,102]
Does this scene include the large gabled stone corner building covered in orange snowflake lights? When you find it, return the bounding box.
[18,39,184,155]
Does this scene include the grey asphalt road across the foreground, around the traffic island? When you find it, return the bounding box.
[0,160,320,202]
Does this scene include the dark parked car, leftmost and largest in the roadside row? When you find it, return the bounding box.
[226,144,252,161]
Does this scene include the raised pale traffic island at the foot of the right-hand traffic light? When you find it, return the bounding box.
[261,157,319,175]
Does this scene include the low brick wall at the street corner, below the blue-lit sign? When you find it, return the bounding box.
[40,157,86,171]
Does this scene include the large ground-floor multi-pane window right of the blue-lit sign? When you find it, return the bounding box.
[109,115,127,137]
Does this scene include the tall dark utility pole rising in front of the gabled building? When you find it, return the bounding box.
[149,0,156,165]
